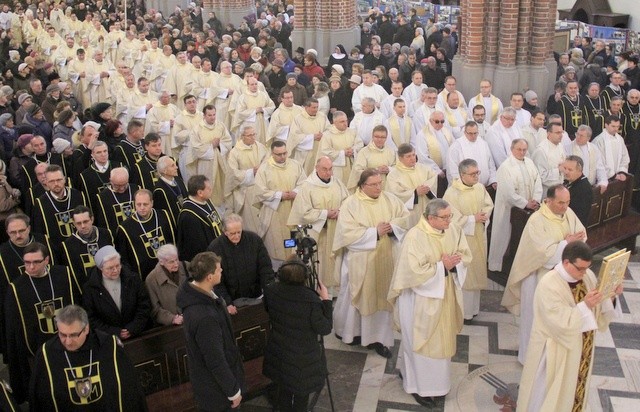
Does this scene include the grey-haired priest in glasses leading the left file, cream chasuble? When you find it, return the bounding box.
[388,199,471,408]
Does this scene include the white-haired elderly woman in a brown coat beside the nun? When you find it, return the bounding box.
[144,243,188,325]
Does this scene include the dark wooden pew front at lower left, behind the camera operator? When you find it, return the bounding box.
[124,305,270,412]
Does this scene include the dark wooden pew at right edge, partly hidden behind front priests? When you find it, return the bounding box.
[498,175,640,286]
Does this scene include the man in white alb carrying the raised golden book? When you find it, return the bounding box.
[518,242,623,412]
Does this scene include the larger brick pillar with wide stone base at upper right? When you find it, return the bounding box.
[453,0,557,110]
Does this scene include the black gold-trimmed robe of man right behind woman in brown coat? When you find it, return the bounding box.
[116,209,175,280]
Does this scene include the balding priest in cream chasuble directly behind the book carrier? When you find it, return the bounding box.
[502,184,587,364]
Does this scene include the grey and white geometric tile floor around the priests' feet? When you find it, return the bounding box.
[5,246,640,412]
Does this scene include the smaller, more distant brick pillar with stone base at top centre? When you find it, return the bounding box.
[291,0,360,64]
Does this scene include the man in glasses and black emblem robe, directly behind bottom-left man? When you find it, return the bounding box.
[4,242,80,403]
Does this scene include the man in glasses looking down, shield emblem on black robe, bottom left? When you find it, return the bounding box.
[29,305,146,411]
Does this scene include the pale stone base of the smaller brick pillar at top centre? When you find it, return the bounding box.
[291,26,360,65]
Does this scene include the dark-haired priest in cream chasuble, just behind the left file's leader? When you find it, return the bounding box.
[333,169,409,358]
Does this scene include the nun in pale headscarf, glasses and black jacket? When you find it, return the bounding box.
[82,246,151,340]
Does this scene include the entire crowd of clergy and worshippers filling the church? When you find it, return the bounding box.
[0,0,640,410]
